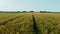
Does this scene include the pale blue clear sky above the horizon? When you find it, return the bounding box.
[0,0,60,12]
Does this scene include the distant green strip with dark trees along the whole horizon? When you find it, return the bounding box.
[0,11,60,13]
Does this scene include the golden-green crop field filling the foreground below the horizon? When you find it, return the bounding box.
[0,13,60,34]
